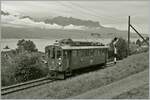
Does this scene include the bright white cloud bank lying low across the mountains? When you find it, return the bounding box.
[1,10,85,30]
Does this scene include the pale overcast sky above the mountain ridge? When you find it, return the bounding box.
[1,1,150,34]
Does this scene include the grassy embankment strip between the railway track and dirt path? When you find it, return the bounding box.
[2,53,149,99]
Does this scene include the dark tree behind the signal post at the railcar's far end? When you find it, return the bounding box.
[109,37,128,59]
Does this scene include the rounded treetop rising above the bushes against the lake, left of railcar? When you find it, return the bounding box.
[17,39,38,52]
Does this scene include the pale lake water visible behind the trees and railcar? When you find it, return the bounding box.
[1,38,137,52]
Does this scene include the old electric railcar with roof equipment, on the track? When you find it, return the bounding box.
[45,41,108,79]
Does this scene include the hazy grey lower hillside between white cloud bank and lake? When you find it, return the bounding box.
[1,26,147,39]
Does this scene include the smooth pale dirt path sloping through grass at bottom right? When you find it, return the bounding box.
[72,69,149,99]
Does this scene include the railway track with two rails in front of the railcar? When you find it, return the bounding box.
[1,77,54,95]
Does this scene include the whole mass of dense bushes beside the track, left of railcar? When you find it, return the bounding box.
[1,50,48,86]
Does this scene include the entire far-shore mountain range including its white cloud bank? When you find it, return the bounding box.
[1,11,147,39]
